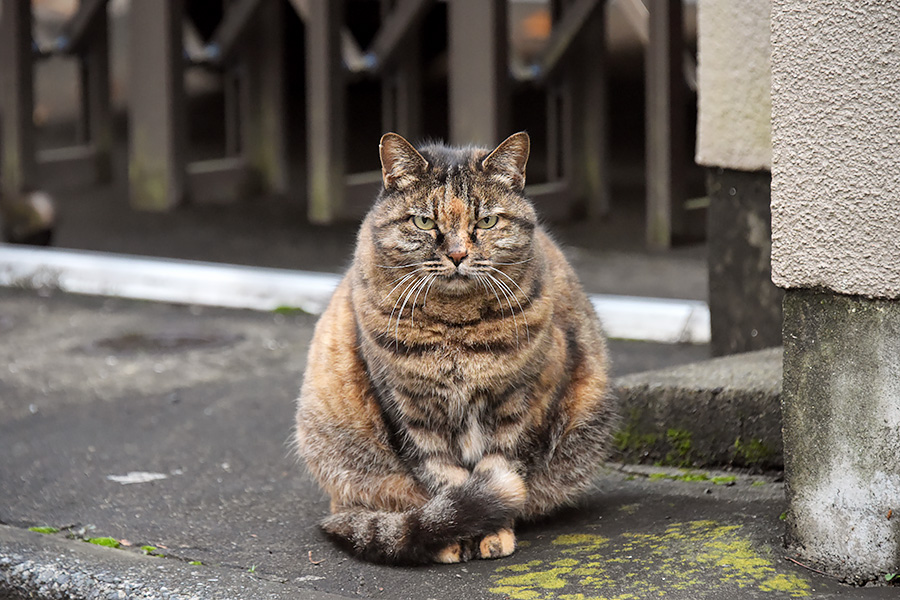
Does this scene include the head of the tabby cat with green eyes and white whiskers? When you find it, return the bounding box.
[369,132,537,294]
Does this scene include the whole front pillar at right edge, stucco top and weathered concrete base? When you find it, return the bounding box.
[771,0,900,582]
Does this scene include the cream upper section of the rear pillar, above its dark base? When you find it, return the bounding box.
[697,0,772,171]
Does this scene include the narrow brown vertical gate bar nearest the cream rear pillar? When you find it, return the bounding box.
[646,0,685,249]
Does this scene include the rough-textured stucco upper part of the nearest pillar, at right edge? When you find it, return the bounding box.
[772,0,900,298]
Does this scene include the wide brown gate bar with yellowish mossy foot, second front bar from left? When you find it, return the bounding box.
[128,0,187,211]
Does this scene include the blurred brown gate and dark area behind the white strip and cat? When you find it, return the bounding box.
[0,0,708,300]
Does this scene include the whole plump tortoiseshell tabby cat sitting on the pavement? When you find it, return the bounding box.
[296,132,616,564]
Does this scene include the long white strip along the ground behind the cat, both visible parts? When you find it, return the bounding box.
[0,244,709,344]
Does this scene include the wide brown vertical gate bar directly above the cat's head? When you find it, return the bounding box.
[448,0,509,146]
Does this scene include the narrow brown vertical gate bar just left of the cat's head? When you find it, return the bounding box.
[306,0,346,223]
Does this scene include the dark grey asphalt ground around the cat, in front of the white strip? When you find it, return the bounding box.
[0,290,896,600]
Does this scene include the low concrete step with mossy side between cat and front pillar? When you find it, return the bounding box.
[615,348,784,469]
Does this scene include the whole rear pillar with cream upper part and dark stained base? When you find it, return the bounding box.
[696,0,783,356]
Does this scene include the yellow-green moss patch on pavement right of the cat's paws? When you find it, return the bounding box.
[490,521,811,600]
